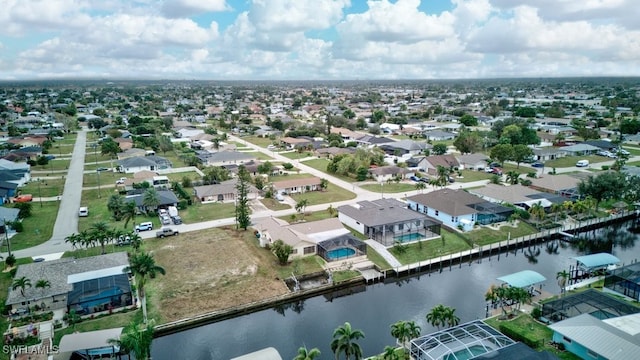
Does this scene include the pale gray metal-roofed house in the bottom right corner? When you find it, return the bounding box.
[549,314,640,360]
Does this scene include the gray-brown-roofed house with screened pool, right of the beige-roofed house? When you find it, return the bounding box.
[336,199,441,246]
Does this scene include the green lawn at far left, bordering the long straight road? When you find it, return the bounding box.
[11,201,59,250]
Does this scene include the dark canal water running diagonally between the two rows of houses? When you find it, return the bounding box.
[152,222,640,360]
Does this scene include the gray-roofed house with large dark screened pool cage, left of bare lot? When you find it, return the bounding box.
[6,252,133,315]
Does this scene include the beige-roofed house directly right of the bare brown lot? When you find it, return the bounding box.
[254,217,350,258]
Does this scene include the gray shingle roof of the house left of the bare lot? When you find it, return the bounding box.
[6,252,129,305]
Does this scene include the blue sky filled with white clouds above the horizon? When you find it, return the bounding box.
[0,0,640,80]
